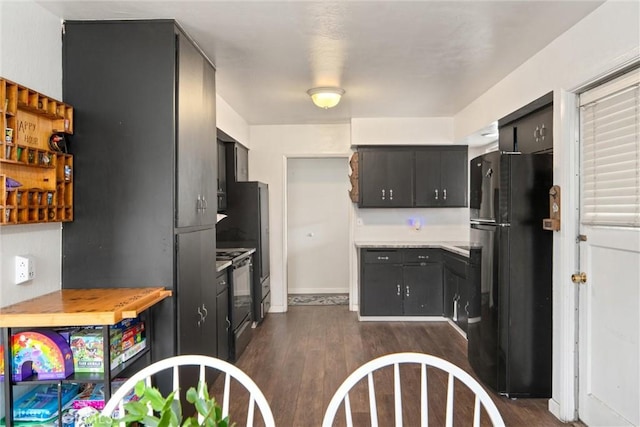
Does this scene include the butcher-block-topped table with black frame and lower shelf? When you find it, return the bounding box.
[0,288,171,427]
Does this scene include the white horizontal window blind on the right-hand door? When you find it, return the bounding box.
[580,70,640,227]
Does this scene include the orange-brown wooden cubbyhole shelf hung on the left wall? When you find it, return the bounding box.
[0,78,73,225]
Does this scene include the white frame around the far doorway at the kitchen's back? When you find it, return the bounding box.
[282,152,357,312]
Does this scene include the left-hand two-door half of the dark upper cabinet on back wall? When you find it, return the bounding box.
[359,148,413,208]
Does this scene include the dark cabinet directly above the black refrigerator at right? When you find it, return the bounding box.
[498,92,553,154]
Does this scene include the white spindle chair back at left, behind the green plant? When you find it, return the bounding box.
[102,355,275,427]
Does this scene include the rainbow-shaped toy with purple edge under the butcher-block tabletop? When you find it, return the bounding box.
[2,330,73,381]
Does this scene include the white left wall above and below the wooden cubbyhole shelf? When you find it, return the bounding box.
[0,1,62,306]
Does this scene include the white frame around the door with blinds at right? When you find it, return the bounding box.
[548,56,639,422]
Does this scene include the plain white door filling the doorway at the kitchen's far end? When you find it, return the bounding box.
[287,157,350,294]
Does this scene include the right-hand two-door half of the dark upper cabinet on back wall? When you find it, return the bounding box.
[415,145,468,207]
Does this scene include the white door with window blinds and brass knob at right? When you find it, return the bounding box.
[578,69,640,426]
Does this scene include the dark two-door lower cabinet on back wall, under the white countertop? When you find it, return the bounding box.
[360,249,442,316]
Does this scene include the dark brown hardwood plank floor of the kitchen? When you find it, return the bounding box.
[213,306,579,427]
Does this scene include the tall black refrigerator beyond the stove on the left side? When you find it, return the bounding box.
[216,181,271,323]
